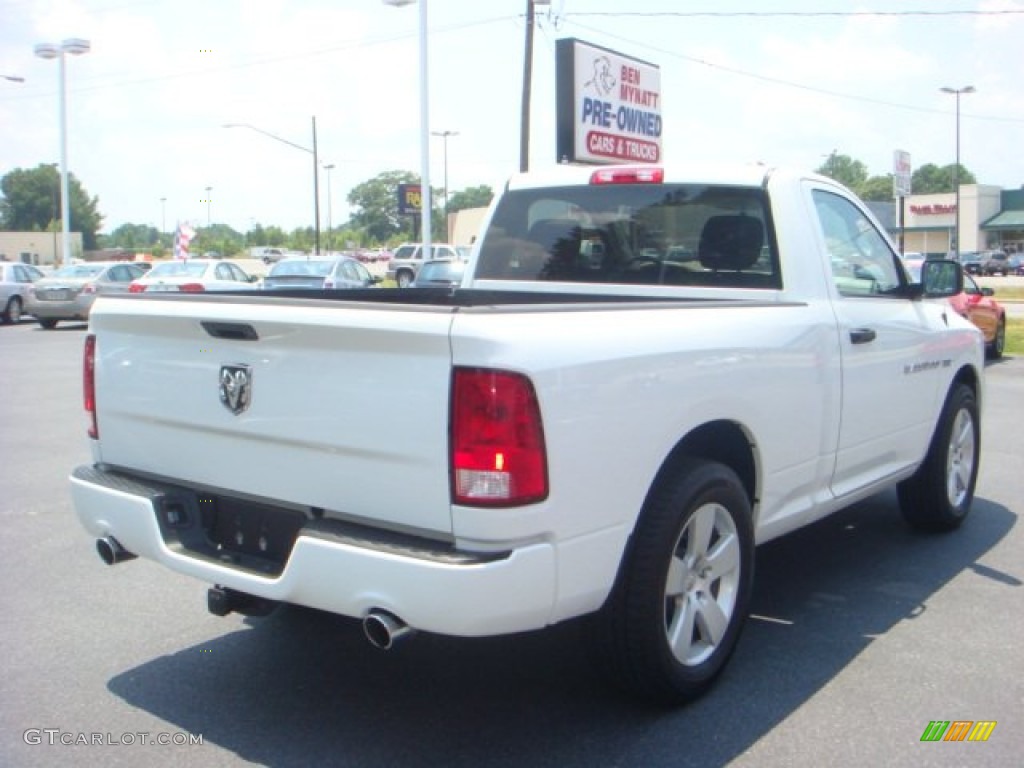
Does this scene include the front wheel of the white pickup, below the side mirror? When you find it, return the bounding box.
[898,384,981,531]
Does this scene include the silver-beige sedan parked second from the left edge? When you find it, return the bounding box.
[32,261,144,331]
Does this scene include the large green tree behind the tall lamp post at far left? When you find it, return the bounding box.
[0,163,103,251]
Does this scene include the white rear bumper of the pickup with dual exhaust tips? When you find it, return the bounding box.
[70,466,557,636]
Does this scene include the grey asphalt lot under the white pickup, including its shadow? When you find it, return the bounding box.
[0,322,1024,768]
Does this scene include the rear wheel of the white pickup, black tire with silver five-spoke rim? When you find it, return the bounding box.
[585,459,754,705]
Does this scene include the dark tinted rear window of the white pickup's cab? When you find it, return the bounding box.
[475,184,782,290]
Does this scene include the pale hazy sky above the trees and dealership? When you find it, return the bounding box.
[0,0,1024,232]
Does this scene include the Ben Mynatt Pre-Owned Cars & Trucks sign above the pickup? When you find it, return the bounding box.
[556,38,662,164]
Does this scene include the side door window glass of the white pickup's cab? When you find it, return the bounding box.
[813,189,900,296]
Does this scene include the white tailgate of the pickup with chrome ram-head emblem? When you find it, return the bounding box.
[90,297,452,539]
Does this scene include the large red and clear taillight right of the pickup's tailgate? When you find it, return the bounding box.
[451,368,548,507]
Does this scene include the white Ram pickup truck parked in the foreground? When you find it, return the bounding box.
[71,166,984,702]
